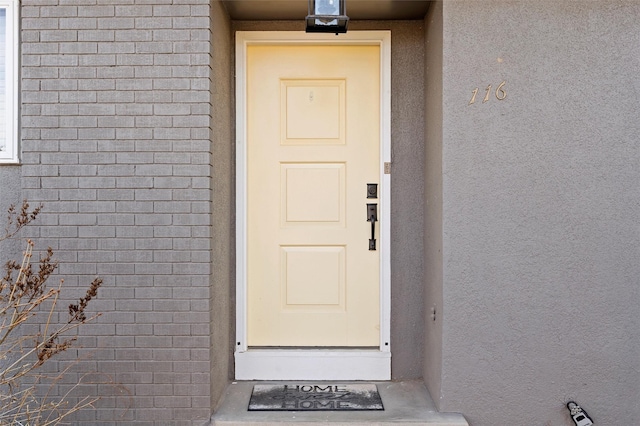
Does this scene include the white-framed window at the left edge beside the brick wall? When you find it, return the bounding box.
[0,0,18,163]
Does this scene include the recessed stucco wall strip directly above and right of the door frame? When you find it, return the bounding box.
[233,21,424,380]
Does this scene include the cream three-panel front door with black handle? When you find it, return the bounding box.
[247,45,385,347]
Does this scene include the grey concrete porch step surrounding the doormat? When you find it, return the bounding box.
[210,381,469,426]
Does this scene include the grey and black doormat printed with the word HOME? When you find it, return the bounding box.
[249,384,384,411]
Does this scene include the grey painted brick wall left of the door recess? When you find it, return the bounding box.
[21,0,212,425]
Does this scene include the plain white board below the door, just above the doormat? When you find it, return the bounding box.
[235,349,391,380]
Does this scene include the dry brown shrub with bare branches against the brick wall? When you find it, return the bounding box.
[0,200,107,426]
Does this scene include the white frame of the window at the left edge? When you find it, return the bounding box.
[0,0,19,164]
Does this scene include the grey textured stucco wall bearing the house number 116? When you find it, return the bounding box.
[440,0,640,426]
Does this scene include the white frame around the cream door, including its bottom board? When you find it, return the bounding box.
[235,31,391,380]
